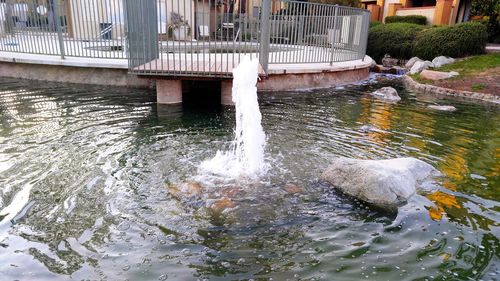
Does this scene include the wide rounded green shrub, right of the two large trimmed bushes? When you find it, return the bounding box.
[413,22,488,60]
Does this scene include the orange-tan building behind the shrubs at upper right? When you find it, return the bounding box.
[361,0,472,25]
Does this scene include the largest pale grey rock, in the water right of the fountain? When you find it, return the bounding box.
[321,158,440,209]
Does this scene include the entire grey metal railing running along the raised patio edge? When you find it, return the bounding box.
[0,0,370,77]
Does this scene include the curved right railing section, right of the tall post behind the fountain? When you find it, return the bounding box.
[269,2,370,64]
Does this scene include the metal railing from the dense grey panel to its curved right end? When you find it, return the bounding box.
[126,0,370,77]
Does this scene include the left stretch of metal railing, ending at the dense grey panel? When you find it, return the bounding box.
[0,0,126,59]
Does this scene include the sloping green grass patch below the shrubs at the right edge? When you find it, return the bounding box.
[436,53,500,79]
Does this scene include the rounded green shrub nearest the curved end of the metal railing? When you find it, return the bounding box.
[367,23,425,62]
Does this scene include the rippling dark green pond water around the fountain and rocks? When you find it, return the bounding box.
[0,75,500,280]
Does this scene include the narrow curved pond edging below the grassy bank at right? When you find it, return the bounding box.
[404,75,500,106]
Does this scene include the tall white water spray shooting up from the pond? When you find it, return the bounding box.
[200,57,266,178]
